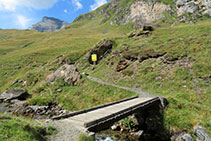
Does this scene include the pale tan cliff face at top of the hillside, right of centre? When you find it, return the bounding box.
[105,0,171,29]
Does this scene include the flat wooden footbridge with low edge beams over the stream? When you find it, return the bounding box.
[53,97,161,132]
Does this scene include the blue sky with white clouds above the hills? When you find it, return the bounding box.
[0,0,109,29]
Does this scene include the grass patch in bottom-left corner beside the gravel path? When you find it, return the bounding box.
[0,113,55,141]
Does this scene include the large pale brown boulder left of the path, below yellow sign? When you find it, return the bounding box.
[46,64,82,86]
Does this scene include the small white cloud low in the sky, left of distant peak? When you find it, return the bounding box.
[15,15,32,29]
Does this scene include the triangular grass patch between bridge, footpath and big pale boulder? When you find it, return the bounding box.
[29,76,137,111]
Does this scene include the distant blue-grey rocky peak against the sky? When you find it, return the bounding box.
[31,16,68,32]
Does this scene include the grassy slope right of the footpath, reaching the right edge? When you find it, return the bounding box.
[84,20,211,133]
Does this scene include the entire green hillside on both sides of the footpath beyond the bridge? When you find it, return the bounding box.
[0,1,211,137]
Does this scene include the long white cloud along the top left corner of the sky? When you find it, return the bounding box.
[0,0,58,11]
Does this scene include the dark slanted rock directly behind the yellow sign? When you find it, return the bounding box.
[88,39,113,64]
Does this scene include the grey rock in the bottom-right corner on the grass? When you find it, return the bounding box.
[194,126,211,141]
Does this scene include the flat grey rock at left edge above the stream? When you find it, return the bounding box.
[0,88,29,101]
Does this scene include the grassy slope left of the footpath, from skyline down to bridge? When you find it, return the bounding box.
[0,14,136,110]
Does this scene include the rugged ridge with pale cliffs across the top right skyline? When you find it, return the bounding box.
[75,0,211,29]
